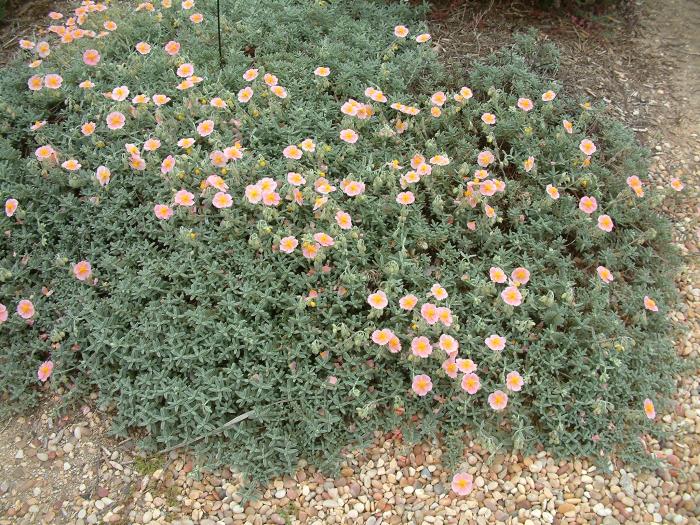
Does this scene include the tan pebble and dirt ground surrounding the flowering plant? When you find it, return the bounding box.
[0,0,700,525]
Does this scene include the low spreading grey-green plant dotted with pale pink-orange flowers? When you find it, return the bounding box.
[0,0,682,494]
